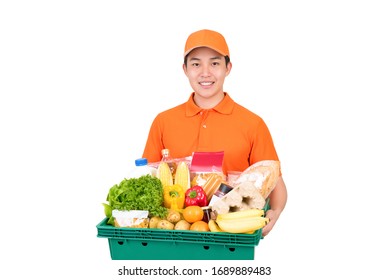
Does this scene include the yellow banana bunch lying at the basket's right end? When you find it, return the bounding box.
[208,209,269,233]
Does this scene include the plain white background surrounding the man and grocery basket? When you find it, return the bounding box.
[0,0,389,279]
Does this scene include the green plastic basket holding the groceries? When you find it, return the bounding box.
[96,199,268,260]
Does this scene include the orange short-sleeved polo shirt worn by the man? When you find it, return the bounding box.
[143,93,278,174]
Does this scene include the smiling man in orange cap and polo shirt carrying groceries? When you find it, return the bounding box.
[143,29,287,235]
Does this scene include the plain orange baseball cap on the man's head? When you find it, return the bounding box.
[184,29,230,57]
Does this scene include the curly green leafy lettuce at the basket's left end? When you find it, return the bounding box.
[103,175,167,224]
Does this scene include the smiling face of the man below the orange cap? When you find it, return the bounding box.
[183,47,231,104]
